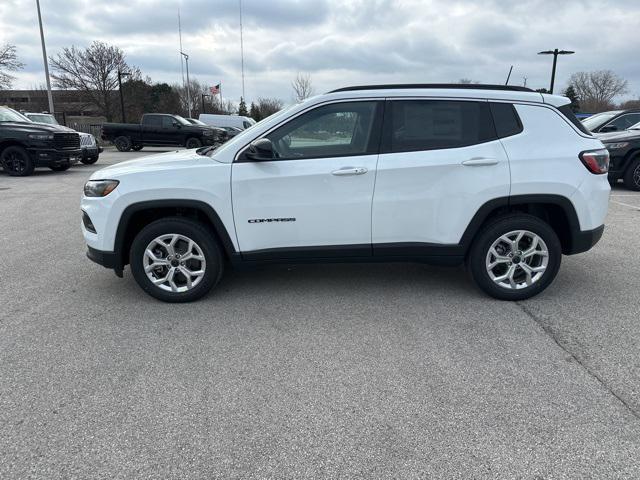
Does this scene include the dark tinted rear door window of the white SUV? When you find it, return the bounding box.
[385,100,496,152]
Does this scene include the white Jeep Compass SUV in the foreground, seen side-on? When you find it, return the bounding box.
[82,85,610,302]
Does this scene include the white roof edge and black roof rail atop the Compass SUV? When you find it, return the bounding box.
[327,83,570,107]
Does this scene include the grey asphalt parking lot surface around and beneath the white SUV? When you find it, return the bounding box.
[0,149,640,479]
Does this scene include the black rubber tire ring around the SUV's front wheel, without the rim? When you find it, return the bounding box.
[129,218,224,303]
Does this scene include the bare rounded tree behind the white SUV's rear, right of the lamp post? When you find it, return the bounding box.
[569,70,627,112]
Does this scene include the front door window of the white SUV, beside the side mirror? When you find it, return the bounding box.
[267,102,377,159]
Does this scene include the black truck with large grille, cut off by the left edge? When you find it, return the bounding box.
[0,107,82,177]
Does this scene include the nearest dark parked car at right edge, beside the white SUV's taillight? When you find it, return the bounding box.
[596,123,640,191]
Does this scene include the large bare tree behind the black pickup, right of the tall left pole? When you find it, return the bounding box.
[49,41,141,121]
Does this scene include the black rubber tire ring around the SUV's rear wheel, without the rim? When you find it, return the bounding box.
[467,214,562,301]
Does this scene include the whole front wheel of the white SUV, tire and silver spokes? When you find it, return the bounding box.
[129,217,224,303]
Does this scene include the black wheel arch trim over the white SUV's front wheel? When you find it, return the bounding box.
[113,199,236,271]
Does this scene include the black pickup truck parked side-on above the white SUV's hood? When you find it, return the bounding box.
[102,113,228,152]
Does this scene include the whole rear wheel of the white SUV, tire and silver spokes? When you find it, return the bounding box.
[467,214,562,300]
